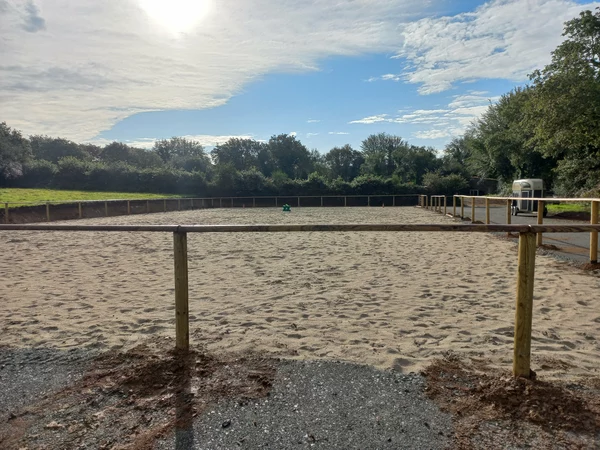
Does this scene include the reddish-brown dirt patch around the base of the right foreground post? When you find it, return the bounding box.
[423,355,600,449]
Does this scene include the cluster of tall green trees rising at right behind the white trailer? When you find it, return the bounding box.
[445,9,600,196]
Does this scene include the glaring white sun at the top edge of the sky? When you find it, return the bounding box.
[138,0,211,33]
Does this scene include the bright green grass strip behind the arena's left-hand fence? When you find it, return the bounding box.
[0,188,181,206]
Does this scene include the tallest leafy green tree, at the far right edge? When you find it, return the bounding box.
[528,9,600,193]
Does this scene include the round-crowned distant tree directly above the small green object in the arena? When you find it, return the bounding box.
[267,134,313,179]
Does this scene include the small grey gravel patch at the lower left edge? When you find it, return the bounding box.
[0,348,95,418]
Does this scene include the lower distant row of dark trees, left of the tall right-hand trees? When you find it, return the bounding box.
[0,123,467,196]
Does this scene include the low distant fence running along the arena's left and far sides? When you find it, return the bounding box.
[0,194,419,224]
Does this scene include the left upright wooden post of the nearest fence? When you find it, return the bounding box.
[173,231,190,351]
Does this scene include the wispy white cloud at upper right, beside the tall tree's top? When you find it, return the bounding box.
[394,0,600,94]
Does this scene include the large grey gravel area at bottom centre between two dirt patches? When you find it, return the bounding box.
[155,361,452,450]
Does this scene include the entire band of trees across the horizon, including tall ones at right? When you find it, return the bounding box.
[0,9,600,196]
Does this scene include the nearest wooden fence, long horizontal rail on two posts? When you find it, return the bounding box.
[0,224,600,377]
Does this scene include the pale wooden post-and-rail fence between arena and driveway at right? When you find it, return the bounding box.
[419,195,600,264]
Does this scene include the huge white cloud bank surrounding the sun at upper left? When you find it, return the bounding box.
[0,0,430,141]
